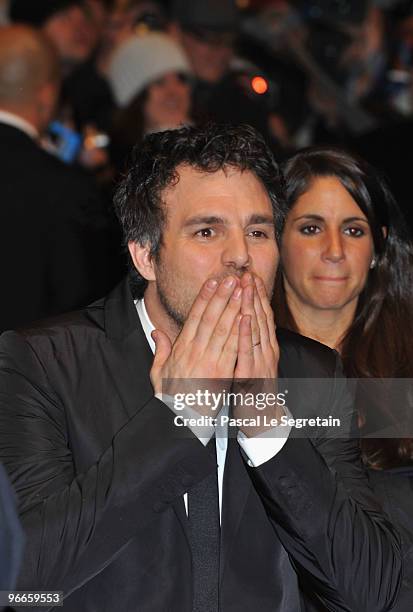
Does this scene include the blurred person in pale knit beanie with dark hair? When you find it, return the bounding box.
[107,32,191,169]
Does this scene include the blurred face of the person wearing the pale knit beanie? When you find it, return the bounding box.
[144,72,190,130]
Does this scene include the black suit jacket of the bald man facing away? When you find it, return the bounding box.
[0,123,120,331]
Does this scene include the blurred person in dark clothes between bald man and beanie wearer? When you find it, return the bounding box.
[9,0,114,173]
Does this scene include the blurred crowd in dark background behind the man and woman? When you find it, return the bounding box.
[0,0,413,329]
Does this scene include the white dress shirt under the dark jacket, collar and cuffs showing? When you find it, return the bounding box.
[135,299,291,517]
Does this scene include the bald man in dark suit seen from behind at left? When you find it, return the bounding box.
[0,26,116,332]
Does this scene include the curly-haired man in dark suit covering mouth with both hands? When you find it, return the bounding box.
[0,126,401,612]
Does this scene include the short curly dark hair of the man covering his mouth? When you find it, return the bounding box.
[114,124,285,285]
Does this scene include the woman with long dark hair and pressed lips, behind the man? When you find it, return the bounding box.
[275,147,413,468]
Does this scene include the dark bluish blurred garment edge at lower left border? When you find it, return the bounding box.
[0,465,23,596]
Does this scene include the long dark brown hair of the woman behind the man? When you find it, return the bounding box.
[276,147,413,467]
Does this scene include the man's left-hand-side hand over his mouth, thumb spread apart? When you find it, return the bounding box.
[150,276,242,394]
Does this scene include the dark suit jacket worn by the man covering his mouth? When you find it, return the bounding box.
[0,282,401,612]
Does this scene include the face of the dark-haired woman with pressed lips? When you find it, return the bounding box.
[281,177,374,311]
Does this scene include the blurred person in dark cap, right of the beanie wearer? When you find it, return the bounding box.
[170,0,278,150]
